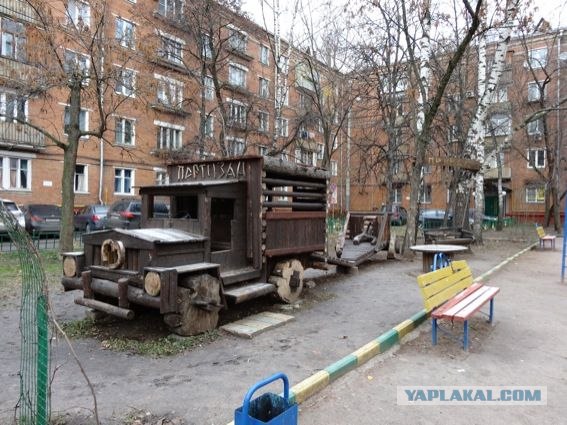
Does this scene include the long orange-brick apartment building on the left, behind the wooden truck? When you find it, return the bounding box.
[0,0,337,207]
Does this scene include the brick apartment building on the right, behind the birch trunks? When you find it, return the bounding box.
[341,28,567,225]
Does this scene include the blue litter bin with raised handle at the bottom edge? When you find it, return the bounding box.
[234,373,297,425]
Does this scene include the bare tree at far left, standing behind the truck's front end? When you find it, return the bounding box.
[9,0,146,251]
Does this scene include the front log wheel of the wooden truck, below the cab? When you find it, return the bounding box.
[164,274,223,336]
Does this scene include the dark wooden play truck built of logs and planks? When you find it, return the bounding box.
[62,156,389,335]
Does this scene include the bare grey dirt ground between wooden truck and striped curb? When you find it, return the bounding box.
[0,228,535,425]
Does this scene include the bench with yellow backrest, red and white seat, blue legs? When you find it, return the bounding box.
[417,260,500,351]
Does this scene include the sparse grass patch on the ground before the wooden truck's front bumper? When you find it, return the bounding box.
[61,318,220,357]
